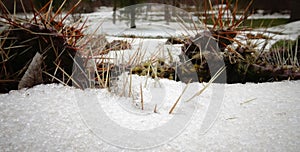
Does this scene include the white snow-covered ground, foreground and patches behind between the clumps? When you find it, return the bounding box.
[0,4,300,152]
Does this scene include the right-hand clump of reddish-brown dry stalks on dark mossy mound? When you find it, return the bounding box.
[183,1,300,83]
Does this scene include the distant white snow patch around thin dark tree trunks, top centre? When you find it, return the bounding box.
[81,3,199,38]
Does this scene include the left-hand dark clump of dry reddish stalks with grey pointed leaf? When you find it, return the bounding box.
[0,1,87,92]
